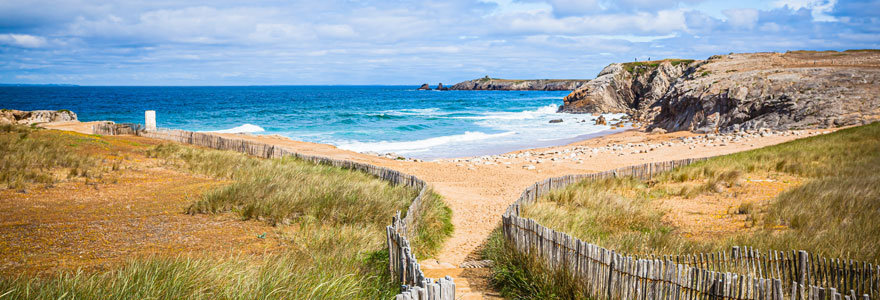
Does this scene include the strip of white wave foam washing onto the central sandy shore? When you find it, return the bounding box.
[337,131,516,154]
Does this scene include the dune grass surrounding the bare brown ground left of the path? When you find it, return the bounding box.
[0,127,452,299]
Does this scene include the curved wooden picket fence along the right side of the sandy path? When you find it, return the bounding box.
[502,158,880,300]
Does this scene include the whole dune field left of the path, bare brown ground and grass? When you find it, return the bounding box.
[0,127,449,299]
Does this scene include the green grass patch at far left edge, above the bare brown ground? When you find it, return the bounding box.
[0,125,100,189]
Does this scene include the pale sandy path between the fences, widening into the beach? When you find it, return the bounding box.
[43,123,824,299]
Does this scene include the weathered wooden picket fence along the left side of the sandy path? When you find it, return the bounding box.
[92,123,455,300]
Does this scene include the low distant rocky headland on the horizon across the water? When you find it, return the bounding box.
[451,77,589,91]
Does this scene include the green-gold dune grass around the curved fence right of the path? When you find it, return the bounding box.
[484,123,880,299]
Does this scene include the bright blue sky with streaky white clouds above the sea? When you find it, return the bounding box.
[0,0,880,85]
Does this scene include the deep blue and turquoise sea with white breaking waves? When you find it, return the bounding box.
[0,86,628,159]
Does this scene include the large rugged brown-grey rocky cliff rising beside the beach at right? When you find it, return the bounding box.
[560,50,880,132]
